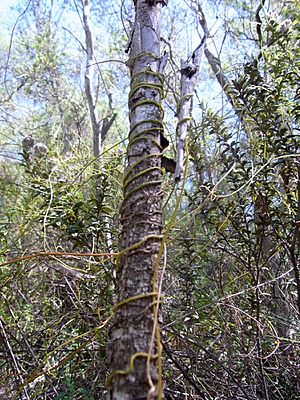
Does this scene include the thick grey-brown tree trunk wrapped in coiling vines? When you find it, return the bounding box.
[108,0,163,400]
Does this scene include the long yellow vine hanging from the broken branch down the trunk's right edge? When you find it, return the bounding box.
[147,140,189,400]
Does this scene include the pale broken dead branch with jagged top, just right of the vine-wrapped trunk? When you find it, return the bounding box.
[175,36,206,181]
